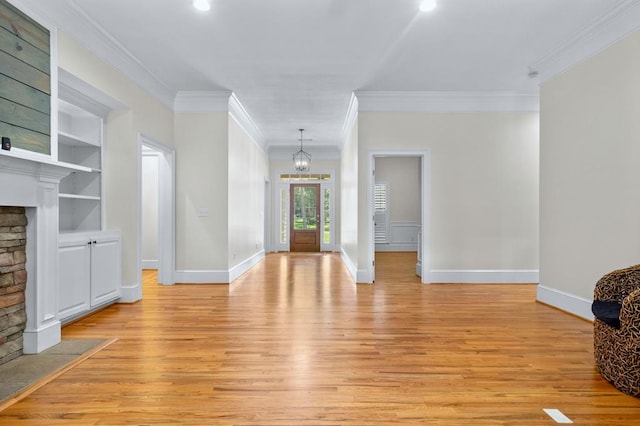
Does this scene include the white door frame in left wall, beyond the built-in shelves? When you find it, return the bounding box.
[137,133,176,292]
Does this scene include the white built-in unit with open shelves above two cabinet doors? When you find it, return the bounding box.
[58,70,122,323]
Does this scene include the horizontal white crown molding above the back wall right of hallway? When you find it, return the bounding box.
[355,91,540,113]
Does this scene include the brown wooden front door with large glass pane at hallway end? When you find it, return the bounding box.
[289,184,320,252]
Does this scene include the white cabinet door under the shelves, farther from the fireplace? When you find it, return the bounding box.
[91,239,121,307]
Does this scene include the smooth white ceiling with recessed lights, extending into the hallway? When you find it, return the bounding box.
[18,0,629,149]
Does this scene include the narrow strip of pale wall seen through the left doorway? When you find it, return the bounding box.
[142,153,158,269]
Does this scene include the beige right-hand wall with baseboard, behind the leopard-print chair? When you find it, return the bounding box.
[538,32,640,318]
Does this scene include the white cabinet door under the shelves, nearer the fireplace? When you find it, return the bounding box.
[58,240,91,320]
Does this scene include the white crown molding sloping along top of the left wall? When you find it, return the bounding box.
[14,0,175,108]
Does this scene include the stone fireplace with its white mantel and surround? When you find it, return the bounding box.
[0,150,74,356]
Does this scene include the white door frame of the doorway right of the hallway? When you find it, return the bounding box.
[365,150,431,284]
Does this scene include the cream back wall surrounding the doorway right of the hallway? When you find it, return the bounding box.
[358,111,539,277]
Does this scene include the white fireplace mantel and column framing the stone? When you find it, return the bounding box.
[0,151,81,354]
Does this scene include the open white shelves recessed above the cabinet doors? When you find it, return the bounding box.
[58,99,103,233]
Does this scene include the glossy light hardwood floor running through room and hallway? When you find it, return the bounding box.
[0,253,640,426]
